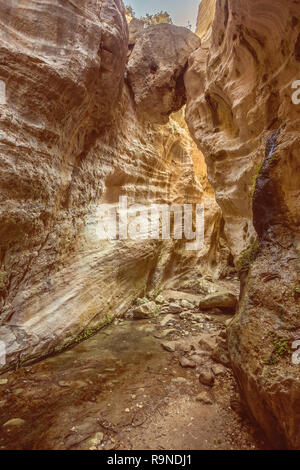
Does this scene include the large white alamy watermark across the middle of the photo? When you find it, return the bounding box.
[96,196,204,251]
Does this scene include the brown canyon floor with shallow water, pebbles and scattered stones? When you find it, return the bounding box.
[0,291,268,450]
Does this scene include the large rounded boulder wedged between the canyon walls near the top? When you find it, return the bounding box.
[128,23,200,124]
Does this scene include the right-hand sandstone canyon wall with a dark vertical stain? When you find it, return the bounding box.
[185,0,300,448]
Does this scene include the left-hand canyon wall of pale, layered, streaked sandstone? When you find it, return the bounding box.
[0,0,228,369]
